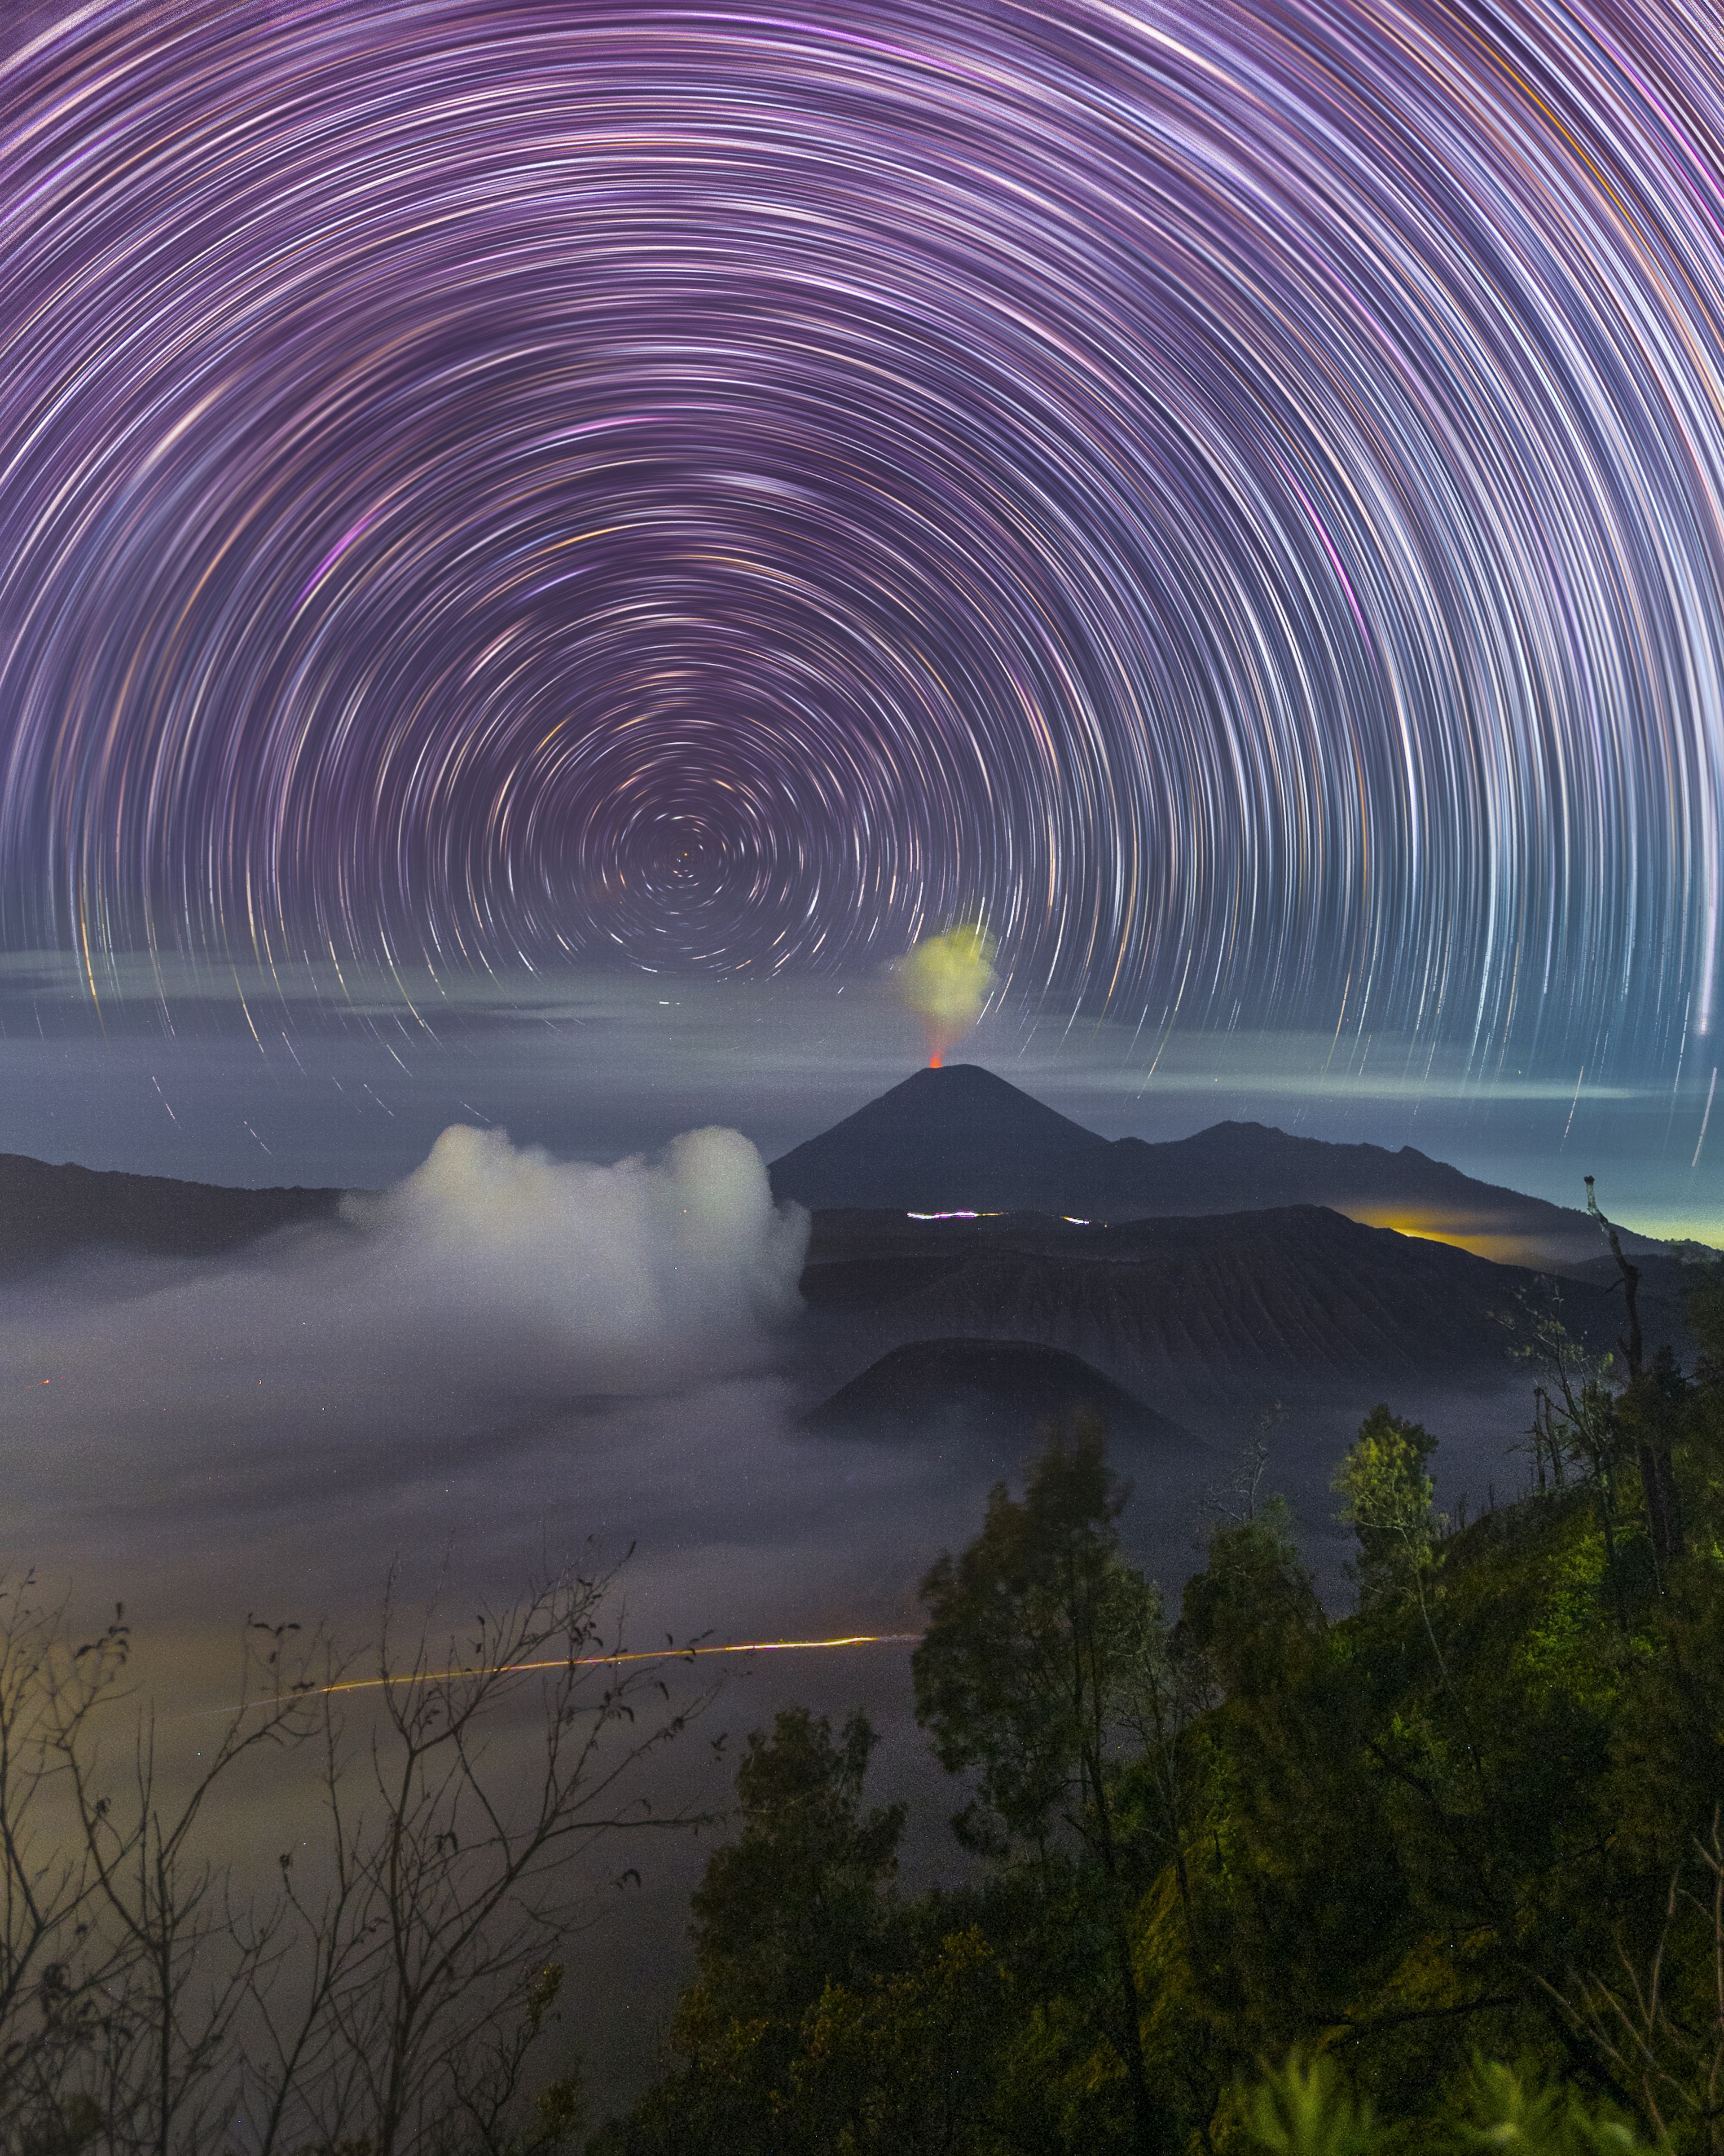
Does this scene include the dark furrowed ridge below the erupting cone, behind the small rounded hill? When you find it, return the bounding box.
[802,1205,1679,1421]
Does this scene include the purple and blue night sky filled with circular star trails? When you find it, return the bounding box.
[0,0,1724,1067]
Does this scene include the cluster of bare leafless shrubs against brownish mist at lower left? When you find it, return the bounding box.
[0,1574,698,2156]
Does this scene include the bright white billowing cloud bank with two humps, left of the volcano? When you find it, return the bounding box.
[0,1128,808,1466]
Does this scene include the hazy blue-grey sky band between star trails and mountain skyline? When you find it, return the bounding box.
[0,953,1724,1244]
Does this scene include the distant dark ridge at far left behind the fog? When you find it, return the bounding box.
[0,1154,340,1272]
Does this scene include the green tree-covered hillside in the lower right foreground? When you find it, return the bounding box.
[616,1281,1724,2156]
